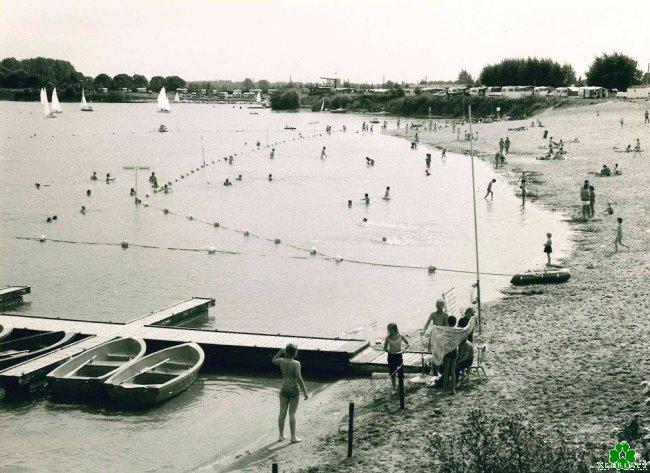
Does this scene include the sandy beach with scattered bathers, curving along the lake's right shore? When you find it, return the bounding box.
[237,100,650,472]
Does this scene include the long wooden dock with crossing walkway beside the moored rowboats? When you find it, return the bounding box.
[0,292,428,389]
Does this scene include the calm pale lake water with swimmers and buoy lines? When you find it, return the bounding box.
[0,102,570,471]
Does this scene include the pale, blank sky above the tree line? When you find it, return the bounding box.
[0,0,650,83]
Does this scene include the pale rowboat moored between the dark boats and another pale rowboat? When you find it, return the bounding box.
[47,338,147,397]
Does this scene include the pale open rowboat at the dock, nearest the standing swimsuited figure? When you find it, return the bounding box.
[104,343,205,407]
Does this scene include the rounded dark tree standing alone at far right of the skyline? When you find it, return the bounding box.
[587,52,643,90]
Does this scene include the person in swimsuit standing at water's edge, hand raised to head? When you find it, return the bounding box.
[272,343,309,443]
